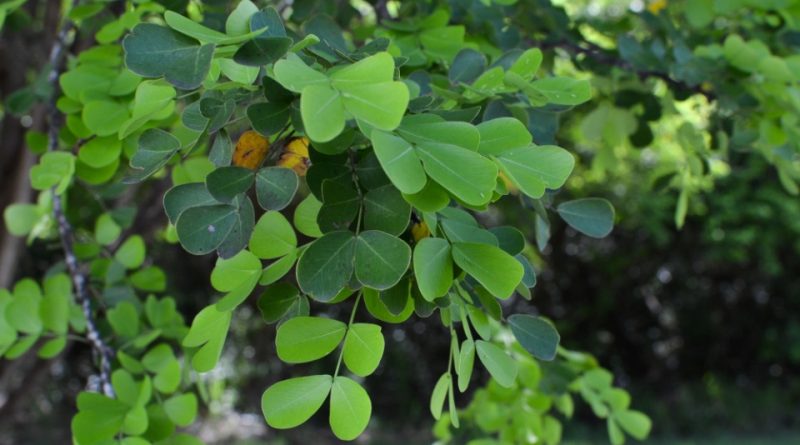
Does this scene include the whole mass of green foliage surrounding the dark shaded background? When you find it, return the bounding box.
[0,0,800,445]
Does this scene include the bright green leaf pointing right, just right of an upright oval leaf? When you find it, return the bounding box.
[453,243,524,299]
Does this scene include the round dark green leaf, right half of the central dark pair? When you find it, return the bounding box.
[355,230,411,290]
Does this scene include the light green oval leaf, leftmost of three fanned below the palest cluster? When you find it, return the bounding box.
[371,131,428,194]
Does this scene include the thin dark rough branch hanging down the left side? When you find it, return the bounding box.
[46,0,114,397]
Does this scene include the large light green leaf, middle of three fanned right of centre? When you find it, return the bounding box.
[417,143,497,206]
